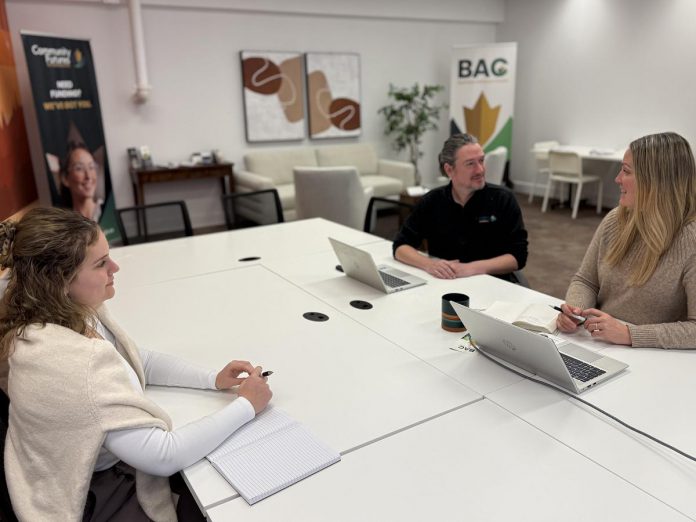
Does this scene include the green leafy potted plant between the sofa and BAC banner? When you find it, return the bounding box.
[377,83,447,185]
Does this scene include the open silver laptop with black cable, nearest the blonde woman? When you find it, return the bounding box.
[452,302,628,393]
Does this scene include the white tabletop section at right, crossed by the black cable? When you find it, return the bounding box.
[488,347,696,518]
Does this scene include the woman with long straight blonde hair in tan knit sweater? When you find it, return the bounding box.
[557,132,696,348]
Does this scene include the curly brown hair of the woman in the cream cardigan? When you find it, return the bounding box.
[0,204,99,359]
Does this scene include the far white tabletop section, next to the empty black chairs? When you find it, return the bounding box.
[111,218,380,288]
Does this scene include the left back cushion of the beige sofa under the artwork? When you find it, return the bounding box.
[244,147,317,185]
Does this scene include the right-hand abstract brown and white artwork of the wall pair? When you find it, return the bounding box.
[305,53,360,138]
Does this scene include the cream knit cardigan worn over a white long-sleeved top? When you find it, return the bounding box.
[5,307,176,521]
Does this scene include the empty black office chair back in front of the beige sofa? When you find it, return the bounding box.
[222,189,284,230]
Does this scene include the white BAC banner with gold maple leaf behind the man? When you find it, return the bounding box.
[450,43,517,159]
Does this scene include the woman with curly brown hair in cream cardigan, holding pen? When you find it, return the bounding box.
[0,208,272,522]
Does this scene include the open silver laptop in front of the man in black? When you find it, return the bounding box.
[329,237,427,294]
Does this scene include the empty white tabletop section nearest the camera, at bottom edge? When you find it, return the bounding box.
[208,400,688,522]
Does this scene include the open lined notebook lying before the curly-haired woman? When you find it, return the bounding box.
[207,407,341,505]
